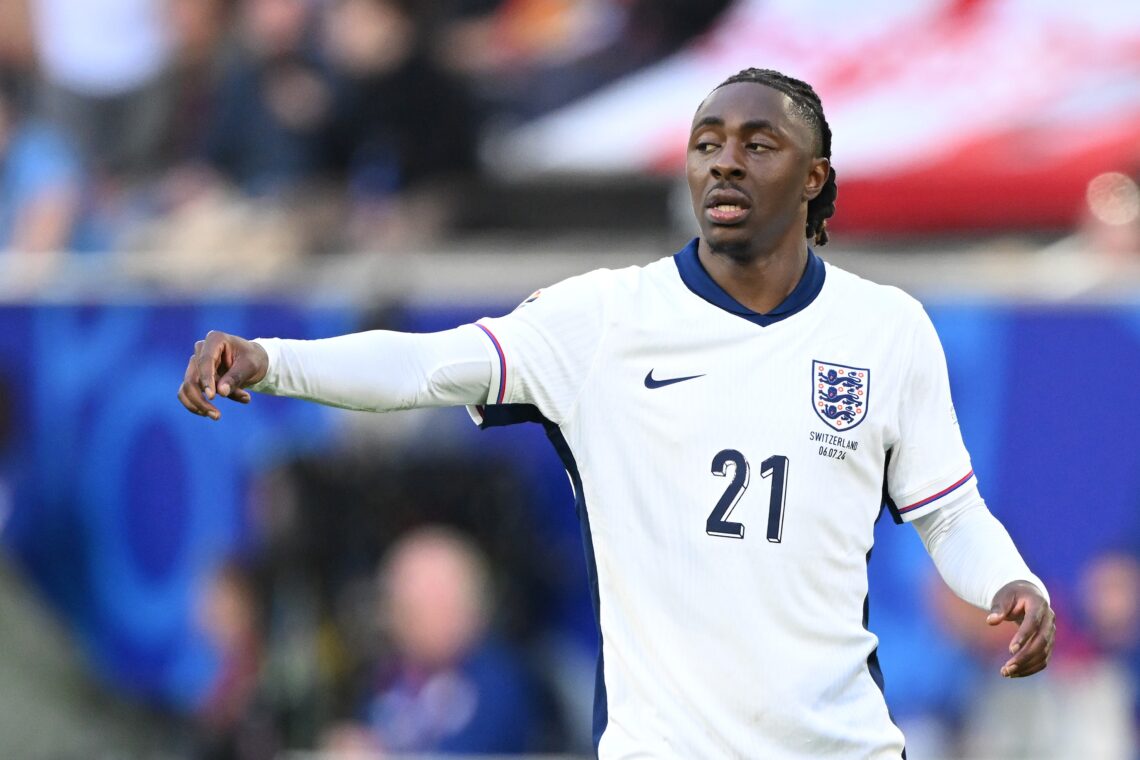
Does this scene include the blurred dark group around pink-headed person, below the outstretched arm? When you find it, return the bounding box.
[183,450,593,760]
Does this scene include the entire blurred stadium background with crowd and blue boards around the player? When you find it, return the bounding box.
[0,0,1140,760]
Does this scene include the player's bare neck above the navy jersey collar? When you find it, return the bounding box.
[697,237,807,313]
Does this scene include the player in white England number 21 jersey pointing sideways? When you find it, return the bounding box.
[179,70,1056,759]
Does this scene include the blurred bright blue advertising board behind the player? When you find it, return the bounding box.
[0,302,1140,709]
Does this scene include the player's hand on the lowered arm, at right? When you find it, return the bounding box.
[986,581,1057,678]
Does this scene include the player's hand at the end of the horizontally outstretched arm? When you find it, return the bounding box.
[178,330,269,419]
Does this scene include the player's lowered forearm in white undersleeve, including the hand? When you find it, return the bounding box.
[913,496,1057,678]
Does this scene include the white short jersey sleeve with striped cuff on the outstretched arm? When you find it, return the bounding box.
[467,270,610,426]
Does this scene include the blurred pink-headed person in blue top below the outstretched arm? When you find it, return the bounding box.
[326,526,538,753]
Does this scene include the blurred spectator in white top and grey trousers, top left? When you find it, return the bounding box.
[32,0,172,180]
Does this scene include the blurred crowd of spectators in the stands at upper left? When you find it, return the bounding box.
[0,0,728,267]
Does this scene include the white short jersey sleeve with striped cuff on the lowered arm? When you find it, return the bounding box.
[886,304,976,522]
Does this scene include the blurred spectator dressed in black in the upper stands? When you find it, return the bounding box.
[325,0,479,247]
